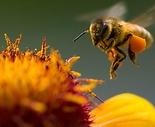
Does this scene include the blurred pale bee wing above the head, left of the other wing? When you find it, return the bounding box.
[76,2,127,22]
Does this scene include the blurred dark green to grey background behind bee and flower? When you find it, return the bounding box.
[0,0,155,104]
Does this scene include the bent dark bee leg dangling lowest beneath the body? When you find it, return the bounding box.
[110,47,126,79]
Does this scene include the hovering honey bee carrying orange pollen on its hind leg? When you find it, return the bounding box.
[74,2,155,79]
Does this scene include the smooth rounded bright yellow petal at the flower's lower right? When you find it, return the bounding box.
[90,93,155,127]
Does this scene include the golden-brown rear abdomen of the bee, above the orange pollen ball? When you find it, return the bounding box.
[127,24,153,48]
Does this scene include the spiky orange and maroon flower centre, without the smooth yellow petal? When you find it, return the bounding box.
[0,34,102,127]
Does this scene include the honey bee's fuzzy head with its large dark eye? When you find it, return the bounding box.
[89,19,108,39]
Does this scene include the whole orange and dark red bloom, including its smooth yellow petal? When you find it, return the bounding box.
[0,34,155,127]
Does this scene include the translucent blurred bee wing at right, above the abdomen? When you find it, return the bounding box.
[130,5,155,27]
